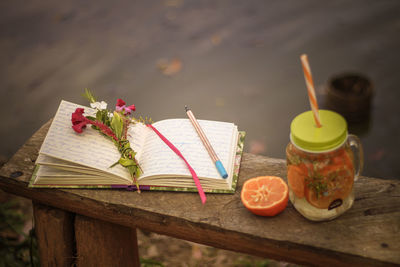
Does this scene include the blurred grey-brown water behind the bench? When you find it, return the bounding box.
[0,0,400,179]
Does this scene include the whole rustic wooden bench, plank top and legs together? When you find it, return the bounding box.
[0,123,400,266]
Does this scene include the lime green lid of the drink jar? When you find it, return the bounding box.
[290,110,347,152]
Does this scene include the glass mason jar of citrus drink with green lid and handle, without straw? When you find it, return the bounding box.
[286,110,363,221]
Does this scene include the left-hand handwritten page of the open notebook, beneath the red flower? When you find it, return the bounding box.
[39,101,147,181]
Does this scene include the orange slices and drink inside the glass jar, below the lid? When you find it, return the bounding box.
[286,143,354,220]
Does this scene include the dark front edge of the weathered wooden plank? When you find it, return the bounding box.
[0,122,393,266]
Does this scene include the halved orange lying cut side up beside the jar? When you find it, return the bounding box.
[240,176,289,216]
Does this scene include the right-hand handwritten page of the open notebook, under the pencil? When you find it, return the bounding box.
[139,119,237,179]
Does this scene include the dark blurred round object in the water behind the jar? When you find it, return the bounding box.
[326,73,373,122]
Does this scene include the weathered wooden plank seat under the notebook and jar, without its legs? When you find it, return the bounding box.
[0,123,400,266]
